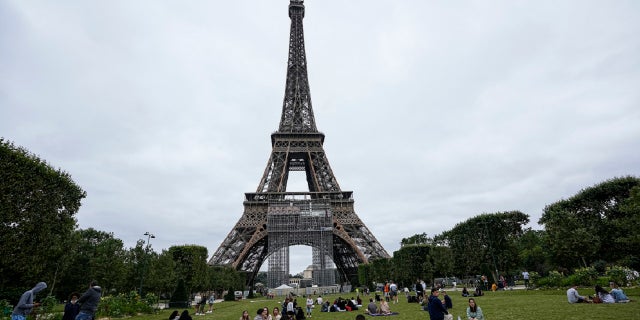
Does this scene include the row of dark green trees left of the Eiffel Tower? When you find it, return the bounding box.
[0,139,245,302]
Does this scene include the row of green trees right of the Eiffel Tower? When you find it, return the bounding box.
[359,177,640,286]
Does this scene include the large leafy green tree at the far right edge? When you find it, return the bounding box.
[538,177,640,269]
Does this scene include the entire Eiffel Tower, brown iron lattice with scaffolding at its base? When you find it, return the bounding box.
[208,0,389,283]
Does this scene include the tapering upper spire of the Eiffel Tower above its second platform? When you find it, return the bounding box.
[278,0,318,133]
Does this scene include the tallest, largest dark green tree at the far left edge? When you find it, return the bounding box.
[0,138,86,299]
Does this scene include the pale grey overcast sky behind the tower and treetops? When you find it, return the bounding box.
[0,0,640,273]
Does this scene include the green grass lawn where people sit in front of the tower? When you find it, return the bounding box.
[133,288,640,320]
